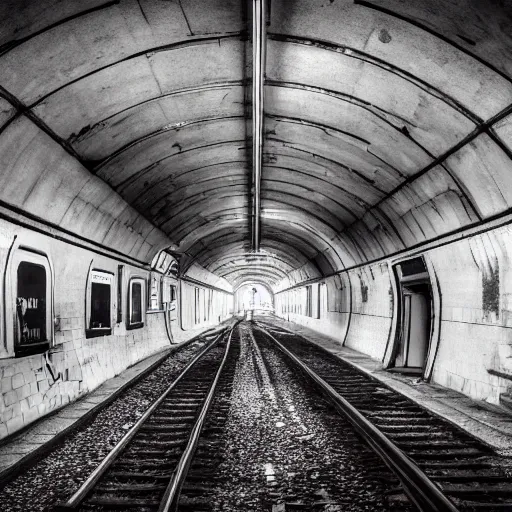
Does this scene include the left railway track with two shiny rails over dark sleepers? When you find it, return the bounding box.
[54,326,238,512]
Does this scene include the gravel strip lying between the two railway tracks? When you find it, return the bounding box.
[204,324,410,512]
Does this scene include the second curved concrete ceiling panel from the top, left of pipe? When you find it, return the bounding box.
[34,41,244,148]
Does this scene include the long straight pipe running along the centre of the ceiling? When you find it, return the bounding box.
[252,0,267,252]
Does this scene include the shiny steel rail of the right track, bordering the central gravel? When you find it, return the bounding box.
[255,325,458,512]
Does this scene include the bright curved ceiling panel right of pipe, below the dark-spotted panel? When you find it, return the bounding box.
[267,41,480,154]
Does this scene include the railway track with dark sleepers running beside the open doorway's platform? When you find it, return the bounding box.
[254,322,512,512]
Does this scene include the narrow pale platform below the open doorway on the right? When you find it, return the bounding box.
[254,316,512,458]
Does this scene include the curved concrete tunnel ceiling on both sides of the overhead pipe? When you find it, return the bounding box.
[0,0,512,288]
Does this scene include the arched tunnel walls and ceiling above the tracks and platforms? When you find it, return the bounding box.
[0,0,512,464]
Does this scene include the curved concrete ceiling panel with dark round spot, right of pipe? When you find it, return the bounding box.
[270,0,512,119]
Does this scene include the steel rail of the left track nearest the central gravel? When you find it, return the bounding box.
[158,324,236,512]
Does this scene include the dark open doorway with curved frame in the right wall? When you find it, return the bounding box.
[390,258,432,376]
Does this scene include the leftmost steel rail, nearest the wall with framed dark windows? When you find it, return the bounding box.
[54,328,227,512]
